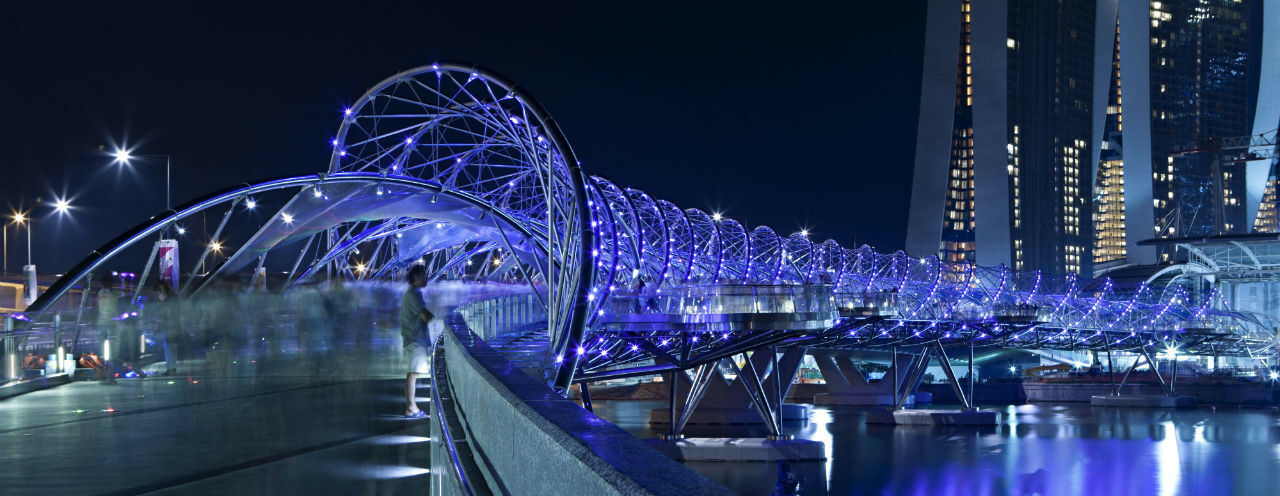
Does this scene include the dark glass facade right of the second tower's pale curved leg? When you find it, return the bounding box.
[1139,0,1249,237]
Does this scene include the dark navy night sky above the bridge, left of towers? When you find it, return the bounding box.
[0,0,924,274]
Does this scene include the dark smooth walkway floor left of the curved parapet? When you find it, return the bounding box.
[0,365,430,495]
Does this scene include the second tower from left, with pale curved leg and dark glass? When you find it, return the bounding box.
[1092,0,1260,270]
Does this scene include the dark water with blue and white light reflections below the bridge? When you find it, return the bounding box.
[596,401,1280,496]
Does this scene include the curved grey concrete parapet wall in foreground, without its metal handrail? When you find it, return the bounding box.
[444,325,731,495]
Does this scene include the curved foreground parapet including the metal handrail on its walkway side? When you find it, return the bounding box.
[433,302,731,495]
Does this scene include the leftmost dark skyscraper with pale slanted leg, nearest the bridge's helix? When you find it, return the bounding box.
[906,0,1096,274]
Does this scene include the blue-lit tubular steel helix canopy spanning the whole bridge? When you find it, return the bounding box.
[12,63,1277,390]
